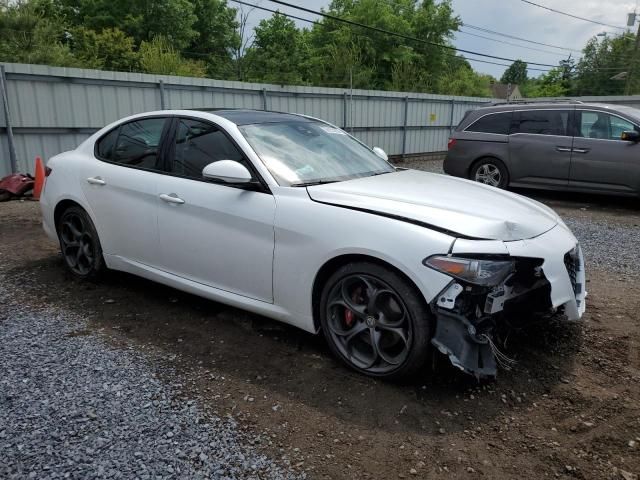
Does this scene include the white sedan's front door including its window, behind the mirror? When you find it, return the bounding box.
[158,118,275,302]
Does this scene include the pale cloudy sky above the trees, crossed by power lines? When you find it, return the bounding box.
[235,0,640,78]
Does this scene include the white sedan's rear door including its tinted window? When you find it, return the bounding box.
[79,117,169,266]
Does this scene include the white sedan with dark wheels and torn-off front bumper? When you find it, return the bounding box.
[41,110,586,378]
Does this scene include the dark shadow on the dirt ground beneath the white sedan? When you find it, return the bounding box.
[7,256,582,435]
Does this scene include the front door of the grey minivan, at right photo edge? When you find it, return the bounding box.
[569,109,640,193]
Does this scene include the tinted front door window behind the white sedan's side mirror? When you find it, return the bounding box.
[172,119,246,178]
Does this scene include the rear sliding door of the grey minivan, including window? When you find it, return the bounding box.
[509,107,573,187]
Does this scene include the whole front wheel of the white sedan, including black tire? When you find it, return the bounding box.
[320,262,432,380]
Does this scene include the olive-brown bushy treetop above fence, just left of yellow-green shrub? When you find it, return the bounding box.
[71,27,139,72]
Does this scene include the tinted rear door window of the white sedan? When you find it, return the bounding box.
[112,118,165,169]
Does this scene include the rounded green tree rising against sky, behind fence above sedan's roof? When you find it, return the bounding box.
[245,13,308,84]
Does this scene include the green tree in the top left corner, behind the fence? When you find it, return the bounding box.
[0,0,78,67]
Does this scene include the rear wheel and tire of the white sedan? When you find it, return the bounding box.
[56,206,106,280]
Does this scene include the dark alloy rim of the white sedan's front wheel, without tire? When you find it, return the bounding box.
[326,274,412,374]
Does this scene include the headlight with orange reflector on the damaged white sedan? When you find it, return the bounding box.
[422,255,515,287]
